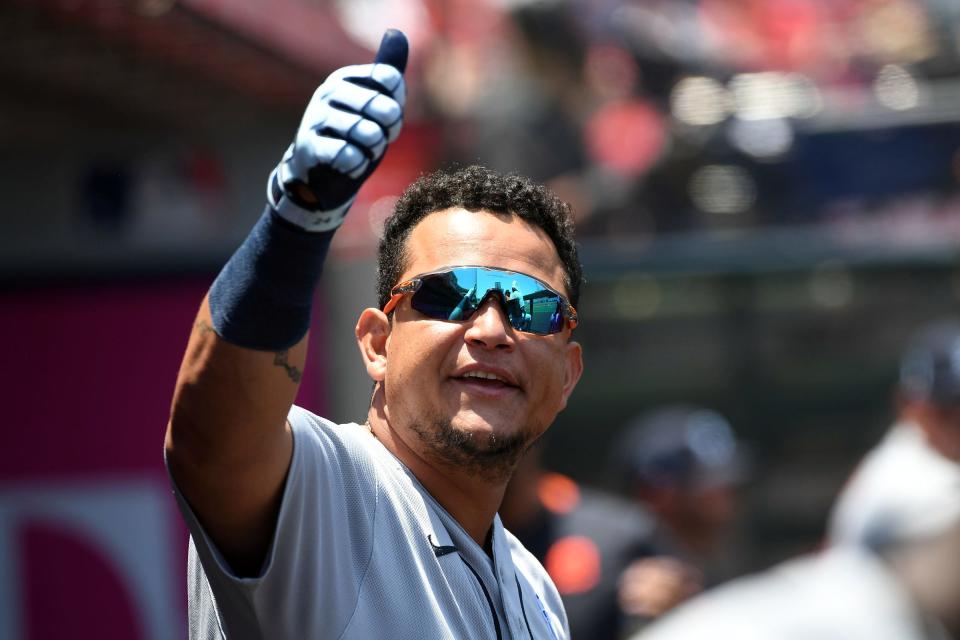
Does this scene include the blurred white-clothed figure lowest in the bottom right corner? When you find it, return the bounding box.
[634,528,960,640]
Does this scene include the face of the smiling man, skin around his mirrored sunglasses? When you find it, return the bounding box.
[385,209,582,480]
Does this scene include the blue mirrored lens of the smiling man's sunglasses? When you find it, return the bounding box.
[410,267,566,335]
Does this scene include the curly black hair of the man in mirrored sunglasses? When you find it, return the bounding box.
[377,165,583,309]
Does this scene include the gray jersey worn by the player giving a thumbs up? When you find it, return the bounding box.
[171,407,569,640]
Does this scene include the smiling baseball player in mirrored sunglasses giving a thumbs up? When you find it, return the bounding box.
[165,31,582,640]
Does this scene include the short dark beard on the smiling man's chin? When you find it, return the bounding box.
[411,418,537,483]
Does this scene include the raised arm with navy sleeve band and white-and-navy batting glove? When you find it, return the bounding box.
[166,30,407,575]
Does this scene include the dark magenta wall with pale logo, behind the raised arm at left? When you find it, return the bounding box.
[0,279,324,640]
